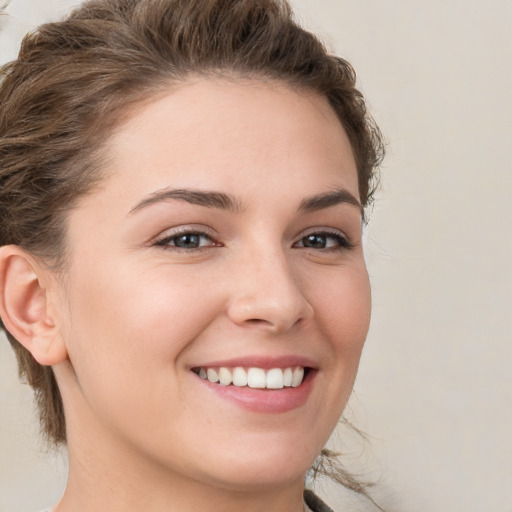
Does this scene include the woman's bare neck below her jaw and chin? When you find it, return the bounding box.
[55,424,304,512]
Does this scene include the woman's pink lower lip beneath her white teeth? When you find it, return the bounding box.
[197,369,316,414]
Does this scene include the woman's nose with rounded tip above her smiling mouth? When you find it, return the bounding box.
[228,247,314,334]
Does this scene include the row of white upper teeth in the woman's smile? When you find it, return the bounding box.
[196,366,304,389]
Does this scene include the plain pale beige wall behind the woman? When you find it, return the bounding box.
[0,0,512,512]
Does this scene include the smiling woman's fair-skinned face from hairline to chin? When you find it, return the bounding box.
[56,79,370,489]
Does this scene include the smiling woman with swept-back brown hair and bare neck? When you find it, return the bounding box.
[0,0,382,512]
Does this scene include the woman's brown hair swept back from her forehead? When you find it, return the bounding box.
[0,0,383,484]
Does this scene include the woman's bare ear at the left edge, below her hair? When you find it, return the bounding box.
[0,245,67,366]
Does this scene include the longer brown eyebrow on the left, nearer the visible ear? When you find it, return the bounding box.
[130,189,244,214]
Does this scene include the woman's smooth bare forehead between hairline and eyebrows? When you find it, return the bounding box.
[81,78,358,216]
